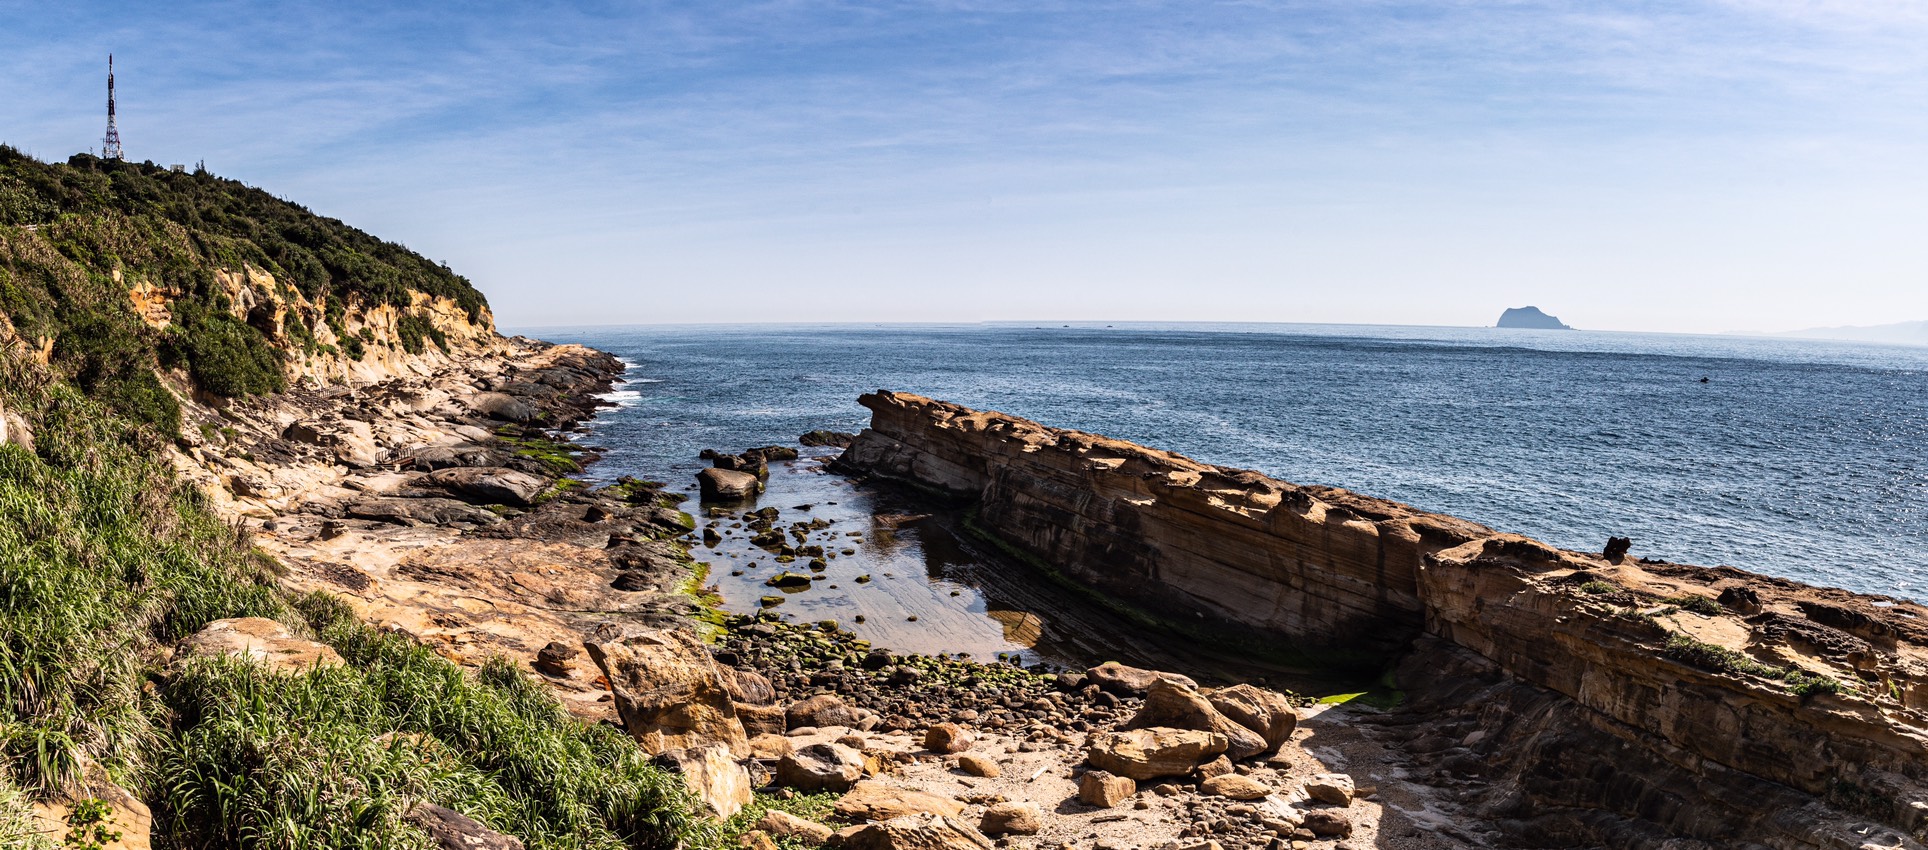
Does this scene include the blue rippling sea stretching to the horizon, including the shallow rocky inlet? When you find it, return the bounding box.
[526,324,1928,646]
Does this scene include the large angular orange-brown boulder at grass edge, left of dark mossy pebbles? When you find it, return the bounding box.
[584,628,750,754]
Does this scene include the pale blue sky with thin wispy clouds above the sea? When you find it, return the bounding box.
[0,0,1928,332]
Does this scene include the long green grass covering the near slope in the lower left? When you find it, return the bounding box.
[0,355,717,850]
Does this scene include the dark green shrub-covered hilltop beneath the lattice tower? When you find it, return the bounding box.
[0,146,488,432]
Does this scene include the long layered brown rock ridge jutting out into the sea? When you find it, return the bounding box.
[844,391,1928,848]
